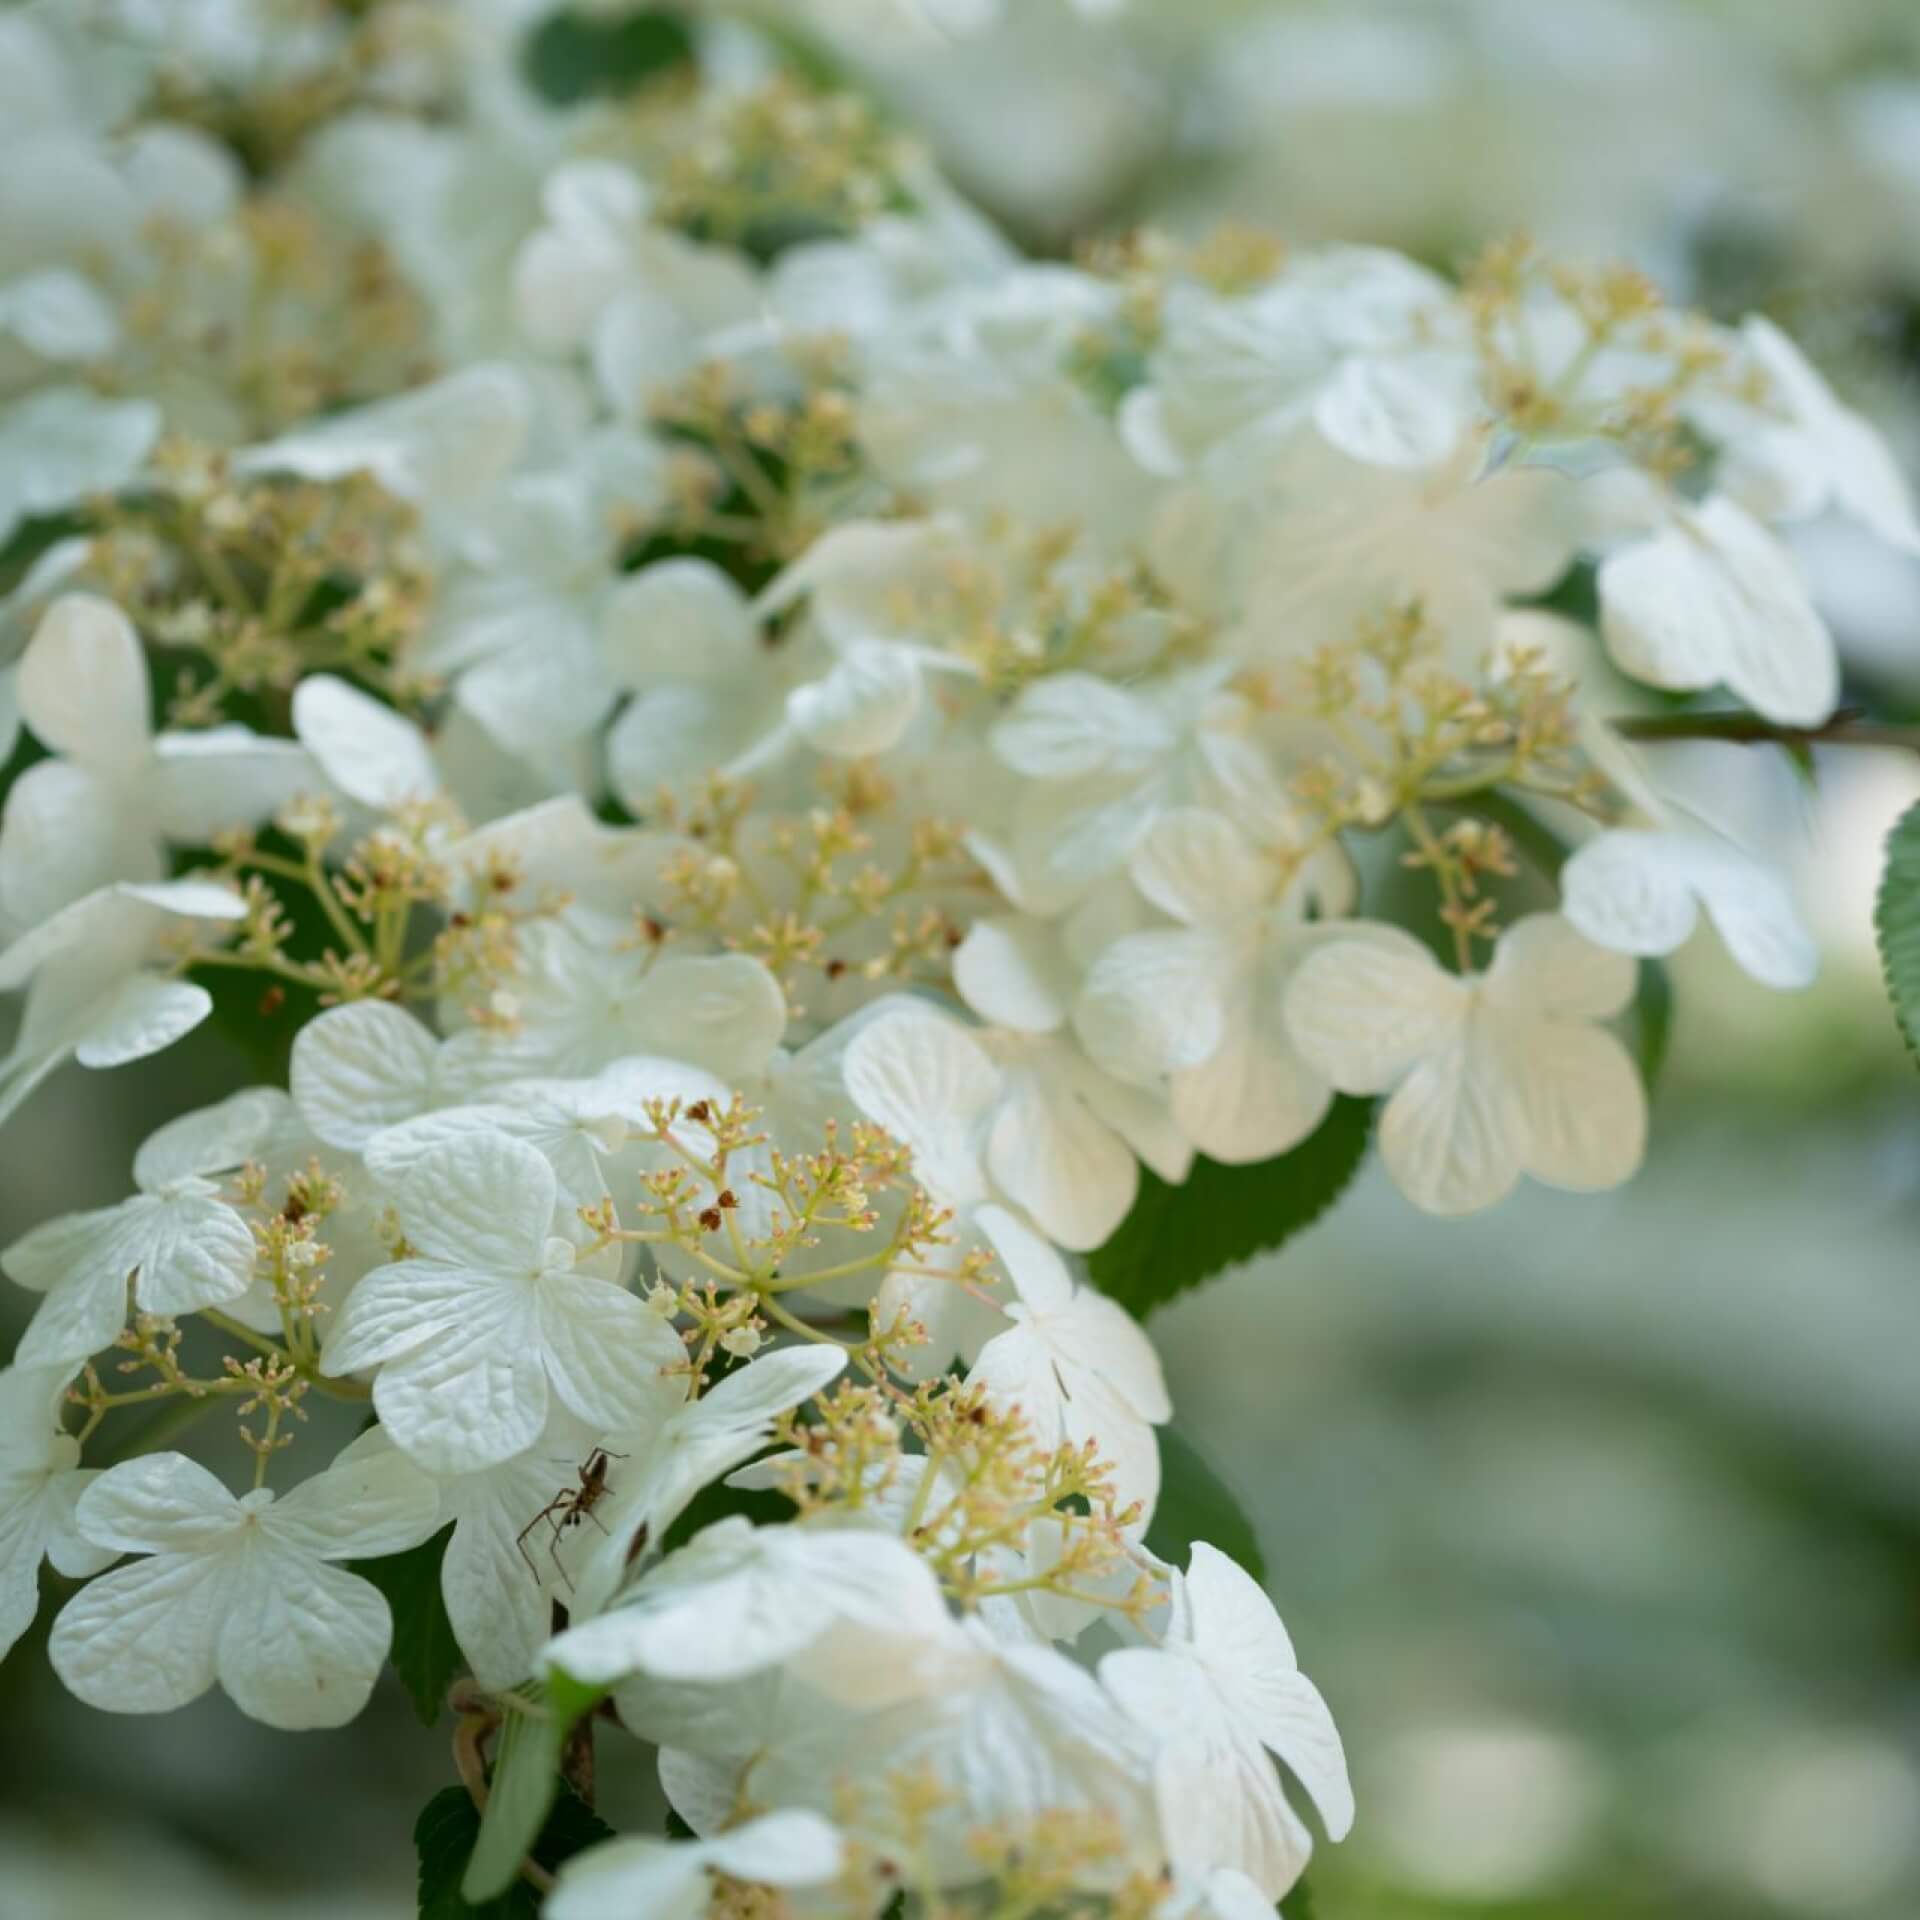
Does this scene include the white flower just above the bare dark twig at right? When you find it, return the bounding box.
[1599,493,1839,726]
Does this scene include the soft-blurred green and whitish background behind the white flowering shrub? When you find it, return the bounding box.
[0,0,1920,1920]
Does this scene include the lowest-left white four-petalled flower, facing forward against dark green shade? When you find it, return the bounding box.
[50,1453,438,1730]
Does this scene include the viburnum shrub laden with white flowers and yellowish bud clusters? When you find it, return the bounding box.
[0,6,1920,1920]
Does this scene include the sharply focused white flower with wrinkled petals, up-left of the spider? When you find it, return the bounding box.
[321,1135,685,1473]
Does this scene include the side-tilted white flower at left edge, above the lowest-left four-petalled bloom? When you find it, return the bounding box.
[0,1092,273,1365]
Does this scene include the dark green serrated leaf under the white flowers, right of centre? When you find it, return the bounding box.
[1091,1094,1373,1319]
